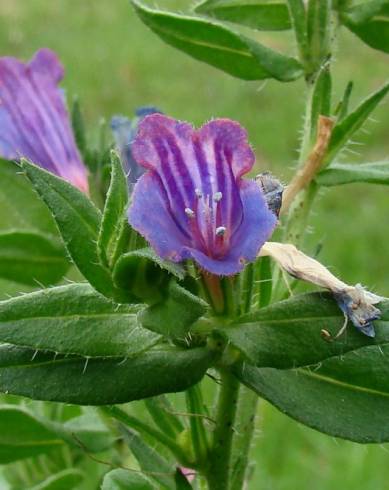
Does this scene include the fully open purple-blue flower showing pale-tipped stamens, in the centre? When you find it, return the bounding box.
[129,114,277,275]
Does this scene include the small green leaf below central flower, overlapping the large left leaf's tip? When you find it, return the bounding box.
[138,281,208,341]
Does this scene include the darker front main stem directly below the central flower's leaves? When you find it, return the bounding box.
[206,371,240,490]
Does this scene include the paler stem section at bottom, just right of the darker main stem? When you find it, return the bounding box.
[230,386,259,490]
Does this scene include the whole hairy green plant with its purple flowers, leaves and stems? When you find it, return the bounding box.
[0,0,389,490]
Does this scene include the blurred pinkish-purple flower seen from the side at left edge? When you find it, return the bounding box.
[0,49,88,193]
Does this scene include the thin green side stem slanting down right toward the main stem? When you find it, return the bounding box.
[100,406,193,467]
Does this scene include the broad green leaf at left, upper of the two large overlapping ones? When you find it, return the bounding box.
[0,284,159,357]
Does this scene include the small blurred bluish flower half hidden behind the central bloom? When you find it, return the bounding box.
[111,107,162,185]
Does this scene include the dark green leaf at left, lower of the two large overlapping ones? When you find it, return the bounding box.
[0,345,213,405]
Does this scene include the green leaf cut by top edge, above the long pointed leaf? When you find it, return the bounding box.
[194,0,291,31]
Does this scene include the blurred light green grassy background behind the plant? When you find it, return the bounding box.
[0,0,389,490]
